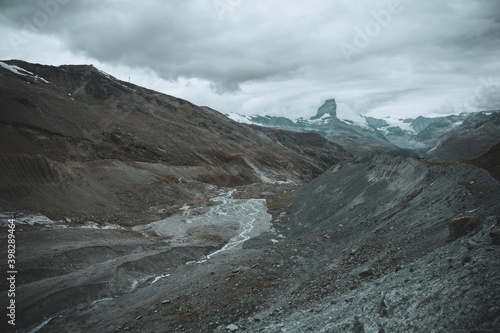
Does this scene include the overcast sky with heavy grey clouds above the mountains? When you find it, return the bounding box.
[0,0,500,118]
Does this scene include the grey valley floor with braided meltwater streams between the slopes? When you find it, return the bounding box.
[2,184,294,333]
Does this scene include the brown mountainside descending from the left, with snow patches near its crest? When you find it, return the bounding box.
[0,61,350,223]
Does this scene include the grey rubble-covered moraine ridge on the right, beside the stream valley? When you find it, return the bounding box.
[236,156,500,332]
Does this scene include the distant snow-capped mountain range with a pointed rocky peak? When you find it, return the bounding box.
[226,99,500,160]
